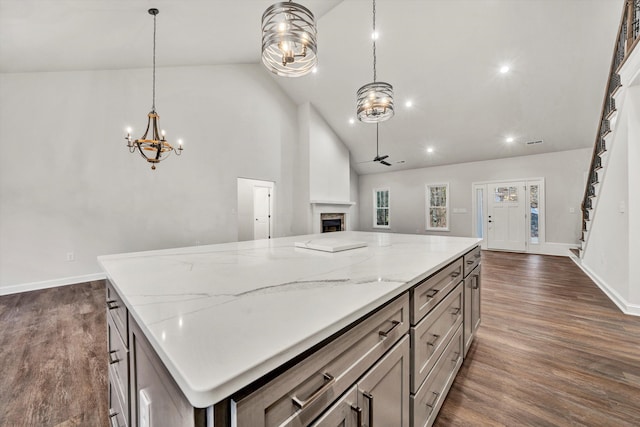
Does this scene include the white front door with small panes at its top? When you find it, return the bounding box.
[486,181,527,251]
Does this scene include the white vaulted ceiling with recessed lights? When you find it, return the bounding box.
[0,0,623,173]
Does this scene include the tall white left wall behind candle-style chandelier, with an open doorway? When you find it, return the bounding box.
[0,64,308,293]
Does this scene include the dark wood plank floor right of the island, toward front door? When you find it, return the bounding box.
[436,252,640,427]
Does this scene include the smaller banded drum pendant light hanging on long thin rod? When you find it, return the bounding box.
[356,0,394,123]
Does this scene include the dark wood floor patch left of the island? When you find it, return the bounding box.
[0,281,109,427]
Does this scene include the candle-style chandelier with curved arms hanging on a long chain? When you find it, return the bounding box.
[125,9,182,170]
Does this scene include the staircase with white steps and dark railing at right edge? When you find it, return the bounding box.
[571,0,640,259]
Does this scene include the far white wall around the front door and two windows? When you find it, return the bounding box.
[359,149,591,244]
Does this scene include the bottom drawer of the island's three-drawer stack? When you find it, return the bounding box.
[411,328,464,427]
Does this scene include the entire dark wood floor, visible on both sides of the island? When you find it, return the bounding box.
[0,252,640,427]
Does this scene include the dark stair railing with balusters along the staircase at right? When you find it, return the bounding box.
[580,0,640,241]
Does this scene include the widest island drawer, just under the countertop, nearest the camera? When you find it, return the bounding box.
[233,293,409,427]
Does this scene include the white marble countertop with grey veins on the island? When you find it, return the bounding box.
[98,232,479,407]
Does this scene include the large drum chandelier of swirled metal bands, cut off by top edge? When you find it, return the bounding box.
[262,1,318,77]
